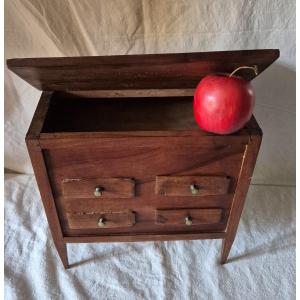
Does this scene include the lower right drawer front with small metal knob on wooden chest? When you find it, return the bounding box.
[155,208,222,226]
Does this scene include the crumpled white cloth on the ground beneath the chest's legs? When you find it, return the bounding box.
[5,175,295,300]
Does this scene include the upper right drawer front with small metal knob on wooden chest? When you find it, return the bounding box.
[155,176,230,196]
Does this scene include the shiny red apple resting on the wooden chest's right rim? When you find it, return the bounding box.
[194,74,255,134]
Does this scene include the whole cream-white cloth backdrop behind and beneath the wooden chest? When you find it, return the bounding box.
[5,0,295,299]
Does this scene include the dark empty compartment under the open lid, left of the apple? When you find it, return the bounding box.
[42,94,198,133]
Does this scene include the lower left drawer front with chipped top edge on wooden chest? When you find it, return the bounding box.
[67,210,135,229]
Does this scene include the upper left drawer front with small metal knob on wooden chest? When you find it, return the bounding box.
[62,178,135,198]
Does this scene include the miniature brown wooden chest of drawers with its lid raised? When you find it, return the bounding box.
[7,50,279,268]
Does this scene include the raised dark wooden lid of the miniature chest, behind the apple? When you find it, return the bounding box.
[7,49,279,91]
